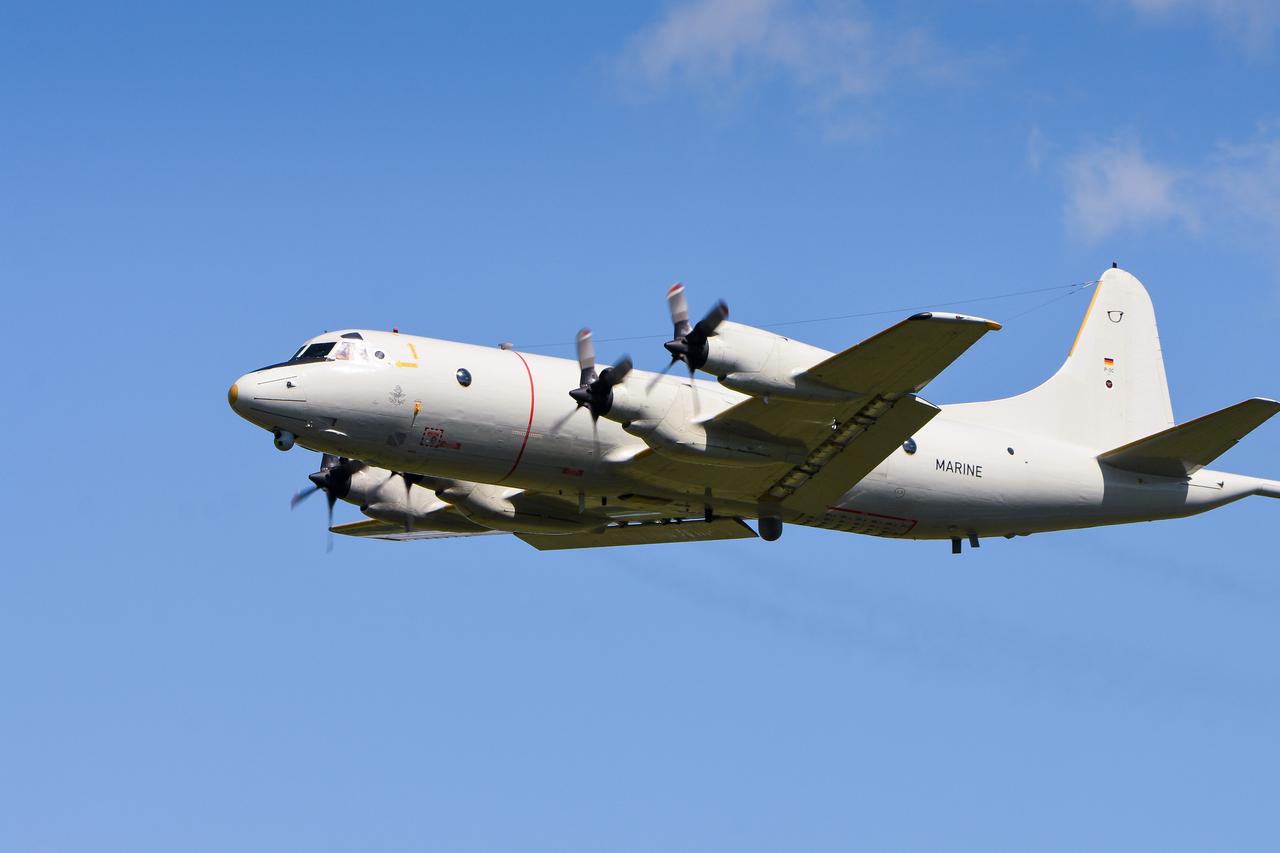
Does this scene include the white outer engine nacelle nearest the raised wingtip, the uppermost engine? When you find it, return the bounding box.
[701,320,855,400]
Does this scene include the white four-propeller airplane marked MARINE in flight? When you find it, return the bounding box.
[228,264,1280,553]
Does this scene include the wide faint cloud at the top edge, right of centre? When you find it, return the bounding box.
[622,0,964,124]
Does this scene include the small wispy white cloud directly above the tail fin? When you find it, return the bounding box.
[1062,141,1197,241]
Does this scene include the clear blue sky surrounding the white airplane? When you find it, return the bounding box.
[0,0,1280,853]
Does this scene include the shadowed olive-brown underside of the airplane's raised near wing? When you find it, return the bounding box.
[636,313,1000,516]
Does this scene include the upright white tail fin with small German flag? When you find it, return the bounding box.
[955,268,1174,451]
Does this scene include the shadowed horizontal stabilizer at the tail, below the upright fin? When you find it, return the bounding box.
[1098,397,1280,476]
